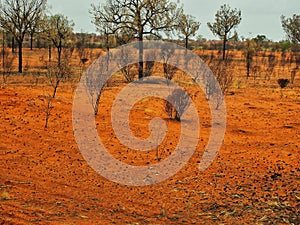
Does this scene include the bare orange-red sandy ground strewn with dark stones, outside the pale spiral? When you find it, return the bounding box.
[0,49,300,225]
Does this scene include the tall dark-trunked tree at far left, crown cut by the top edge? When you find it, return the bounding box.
[0,0,47,73]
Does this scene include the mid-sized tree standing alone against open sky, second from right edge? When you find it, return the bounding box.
[207,4,242,60]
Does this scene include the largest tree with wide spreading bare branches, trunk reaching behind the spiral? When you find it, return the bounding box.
[90,0,182,78]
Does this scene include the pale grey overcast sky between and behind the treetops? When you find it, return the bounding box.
[48,0,300,41]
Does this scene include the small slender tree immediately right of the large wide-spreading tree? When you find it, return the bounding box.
[178,14,201,49]
